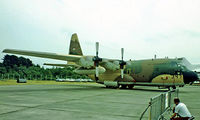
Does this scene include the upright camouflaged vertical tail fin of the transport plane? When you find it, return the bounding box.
[69,33,83,55]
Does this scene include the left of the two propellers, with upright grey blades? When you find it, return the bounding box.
[93,42,102,80]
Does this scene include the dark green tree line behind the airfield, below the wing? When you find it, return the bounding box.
[0,55,88,80]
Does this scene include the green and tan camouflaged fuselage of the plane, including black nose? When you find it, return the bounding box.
[90,58,196,86]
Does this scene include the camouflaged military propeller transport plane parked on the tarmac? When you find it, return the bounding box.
[3,33,200,89]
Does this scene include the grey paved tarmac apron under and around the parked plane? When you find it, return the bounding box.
[0,83,200,120]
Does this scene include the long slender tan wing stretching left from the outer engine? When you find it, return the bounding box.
[3,49,82,61]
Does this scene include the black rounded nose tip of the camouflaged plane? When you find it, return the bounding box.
[183,71,198,84]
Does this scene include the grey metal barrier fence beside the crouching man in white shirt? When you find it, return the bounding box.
[140,89,179,120]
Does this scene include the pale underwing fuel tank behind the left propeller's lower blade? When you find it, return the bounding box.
[74,66,106,75]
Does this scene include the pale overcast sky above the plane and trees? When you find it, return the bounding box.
[0,0,200,64]
